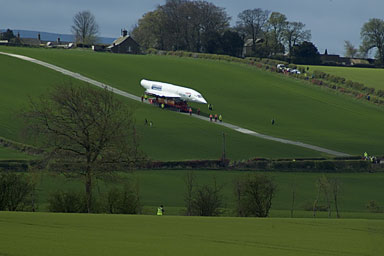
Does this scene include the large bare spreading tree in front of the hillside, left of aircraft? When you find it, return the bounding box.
[24,84,144,212]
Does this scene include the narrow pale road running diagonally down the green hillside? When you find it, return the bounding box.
[0,52,350,156]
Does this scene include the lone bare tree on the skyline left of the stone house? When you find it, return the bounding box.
[72,11,99,44]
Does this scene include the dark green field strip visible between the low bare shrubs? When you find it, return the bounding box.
[30,170,384,218]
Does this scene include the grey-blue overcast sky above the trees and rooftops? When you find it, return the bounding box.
[0,0,384,55]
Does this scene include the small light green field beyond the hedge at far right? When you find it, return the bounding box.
[309,66,384,90]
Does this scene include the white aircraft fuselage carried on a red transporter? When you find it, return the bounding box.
[140,79,207,104]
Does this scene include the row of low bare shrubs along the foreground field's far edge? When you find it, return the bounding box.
[0,171,354,218]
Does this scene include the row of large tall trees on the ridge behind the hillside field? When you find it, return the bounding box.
[132,0,311,57]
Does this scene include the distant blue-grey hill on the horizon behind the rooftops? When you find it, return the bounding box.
[0,29,116,44]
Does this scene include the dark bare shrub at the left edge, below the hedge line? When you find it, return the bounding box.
[0,173,35,211]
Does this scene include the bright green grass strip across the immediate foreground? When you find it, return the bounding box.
[0,212,384,256]
